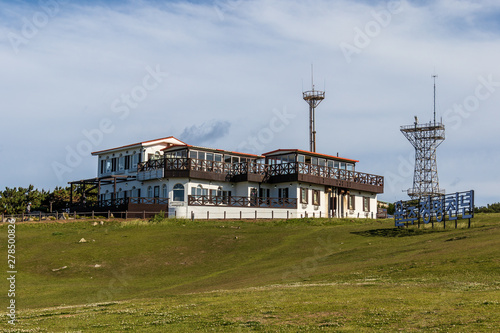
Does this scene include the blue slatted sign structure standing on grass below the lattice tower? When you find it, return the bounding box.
[394,190,474,227]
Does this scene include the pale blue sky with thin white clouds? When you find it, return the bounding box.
[0,0,500,205]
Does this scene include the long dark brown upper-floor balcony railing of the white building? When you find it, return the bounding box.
[139,158,384,187]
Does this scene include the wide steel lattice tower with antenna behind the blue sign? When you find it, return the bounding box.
[401,75,445,199]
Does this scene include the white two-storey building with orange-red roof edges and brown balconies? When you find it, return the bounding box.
[70,137,384,219]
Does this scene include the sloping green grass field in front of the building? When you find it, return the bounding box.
[0,214,500,332]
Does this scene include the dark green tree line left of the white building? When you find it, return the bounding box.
[0,185,97,214]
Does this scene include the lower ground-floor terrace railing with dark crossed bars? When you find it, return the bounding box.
[188,195,297,208]
